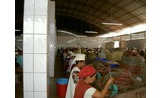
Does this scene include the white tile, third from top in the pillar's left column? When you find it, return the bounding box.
[23,35,33,53]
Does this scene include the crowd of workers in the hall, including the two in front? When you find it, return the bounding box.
[57,47,145,98]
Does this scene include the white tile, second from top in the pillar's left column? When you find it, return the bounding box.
[23,15,34,34]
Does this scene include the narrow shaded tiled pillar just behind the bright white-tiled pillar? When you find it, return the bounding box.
[47,0,57,77]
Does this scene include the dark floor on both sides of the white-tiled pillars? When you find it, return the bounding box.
[15,55,66,98]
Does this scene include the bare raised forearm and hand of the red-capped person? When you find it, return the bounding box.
[92,78,114,98]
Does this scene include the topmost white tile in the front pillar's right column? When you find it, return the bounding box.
[35,0,48,15]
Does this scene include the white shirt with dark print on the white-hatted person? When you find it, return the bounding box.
[65,67,80,98]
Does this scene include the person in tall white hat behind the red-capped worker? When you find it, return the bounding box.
[65,54,85,98]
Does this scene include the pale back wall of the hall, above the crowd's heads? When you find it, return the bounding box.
[15,36,146,49]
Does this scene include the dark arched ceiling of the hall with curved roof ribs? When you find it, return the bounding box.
[15,0,146,37]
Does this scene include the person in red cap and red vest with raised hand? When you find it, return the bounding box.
[74,65,114,98]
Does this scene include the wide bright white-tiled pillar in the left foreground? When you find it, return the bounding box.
[23,0,48,98]
